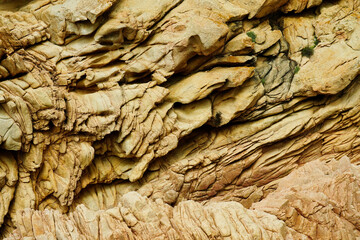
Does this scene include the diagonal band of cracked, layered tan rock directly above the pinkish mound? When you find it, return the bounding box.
[135,77,360,210]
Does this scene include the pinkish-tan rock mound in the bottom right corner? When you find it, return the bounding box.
[252,157,360,239]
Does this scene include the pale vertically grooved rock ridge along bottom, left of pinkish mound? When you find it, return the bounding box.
[7,192,287,239]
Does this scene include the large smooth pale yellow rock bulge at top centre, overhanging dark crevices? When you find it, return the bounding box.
[125,0,248,81]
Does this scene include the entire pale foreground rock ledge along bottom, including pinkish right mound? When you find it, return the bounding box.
[7,157,360,239]
